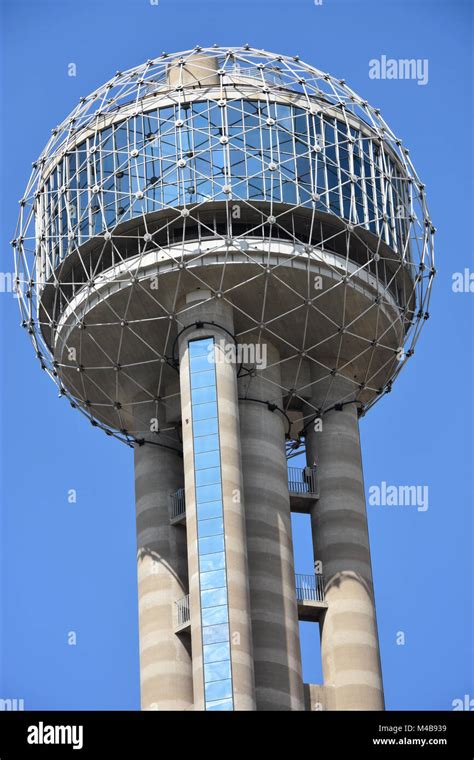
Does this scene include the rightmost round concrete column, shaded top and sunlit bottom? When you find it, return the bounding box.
[306,404,384,710]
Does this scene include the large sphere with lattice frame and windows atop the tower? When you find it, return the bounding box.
[13,45,435,442]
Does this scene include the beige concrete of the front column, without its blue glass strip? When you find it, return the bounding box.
[178,291,255,710]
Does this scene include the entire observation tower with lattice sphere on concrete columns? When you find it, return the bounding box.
[13,45,435,710]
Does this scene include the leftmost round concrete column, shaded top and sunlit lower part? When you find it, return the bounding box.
[135,434,193,710]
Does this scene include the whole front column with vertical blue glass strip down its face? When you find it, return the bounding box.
[178,291,255,710]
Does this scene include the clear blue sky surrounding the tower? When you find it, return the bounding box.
[0,0,474,709]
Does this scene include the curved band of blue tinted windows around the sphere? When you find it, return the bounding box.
[42,100,408,270]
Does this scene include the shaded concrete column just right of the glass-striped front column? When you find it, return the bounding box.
[239,336,304,710]
